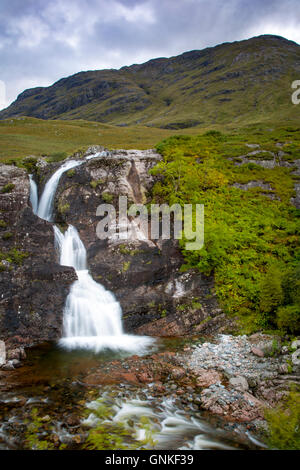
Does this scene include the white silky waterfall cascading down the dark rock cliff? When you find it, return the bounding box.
[30,153,154,353]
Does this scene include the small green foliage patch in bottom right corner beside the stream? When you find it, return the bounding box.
[265,391,300,450]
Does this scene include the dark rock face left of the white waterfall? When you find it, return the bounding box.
[0,165,76,348]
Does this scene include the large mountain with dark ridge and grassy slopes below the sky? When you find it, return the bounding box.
[0,35,300,129]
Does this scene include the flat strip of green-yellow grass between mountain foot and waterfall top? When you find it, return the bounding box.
[0,118,211,164]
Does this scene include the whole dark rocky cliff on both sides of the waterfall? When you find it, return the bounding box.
[0,147,228,349]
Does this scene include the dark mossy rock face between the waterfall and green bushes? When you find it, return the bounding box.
[55,150,226,336]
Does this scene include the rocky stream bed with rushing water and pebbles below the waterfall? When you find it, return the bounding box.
[0,334,299,449]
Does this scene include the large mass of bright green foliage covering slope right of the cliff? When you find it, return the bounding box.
[151,129,300,333]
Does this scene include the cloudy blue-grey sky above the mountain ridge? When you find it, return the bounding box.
[0,0,300,109]
